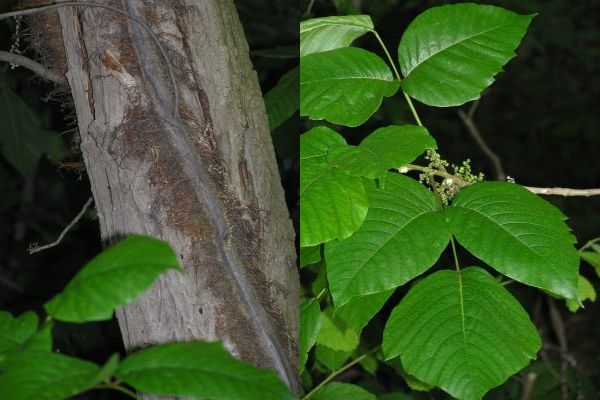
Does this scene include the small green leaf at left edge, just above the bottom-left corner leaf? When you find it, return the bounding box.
[0,311,38,355]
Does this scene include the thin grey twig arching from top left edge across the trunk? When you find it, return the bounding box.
[0,1,179,117]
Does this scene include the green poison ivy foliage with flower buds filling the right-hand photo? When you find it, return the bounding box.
[300,4,593,400]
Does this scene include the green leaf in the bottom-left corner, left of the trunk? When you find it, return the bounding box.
[0,352,100,400]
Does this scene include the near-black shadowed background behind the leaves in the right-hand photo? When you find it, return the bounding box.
[302,0,600,399]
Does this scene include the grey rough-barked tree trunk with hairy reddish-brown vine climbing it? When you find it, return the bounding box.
[51,0,299,391]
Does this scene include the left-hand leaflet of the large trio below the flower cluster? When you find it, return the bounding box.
[325,173,450,309]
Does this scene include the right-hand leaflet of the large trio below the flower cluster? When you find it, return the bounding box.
[445,182,579,301]
